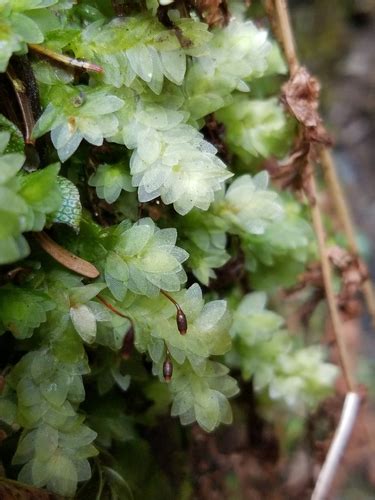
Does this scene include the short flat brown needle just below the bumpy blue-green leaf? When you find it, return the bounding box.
[34,231,100,278]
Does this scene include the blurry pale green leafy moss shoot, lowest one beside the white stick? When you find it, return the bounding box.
[231,292,337,413]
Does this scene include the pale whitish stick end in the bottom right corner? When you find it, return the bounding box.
[311,392,361,500]
